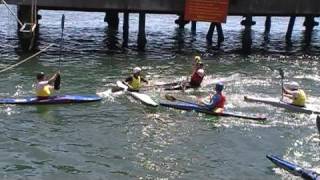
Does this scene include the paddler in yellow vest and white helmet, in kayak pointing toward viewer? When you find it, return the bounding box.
[125,67,148,91]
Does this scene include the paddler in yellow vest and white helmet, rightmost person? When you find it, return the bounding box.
[283,82,307,107]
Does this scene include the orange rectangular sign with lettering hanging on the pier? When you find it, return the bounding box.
[184,0,229,23]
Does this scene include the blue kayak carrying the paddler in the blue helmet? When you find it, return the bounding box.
[160,100,267,121]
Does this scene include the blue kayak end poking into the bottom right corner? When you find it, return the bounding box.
[266,155,320,180]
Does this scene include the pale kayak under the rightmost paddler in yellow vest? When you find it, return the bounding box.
[244,96,320,114]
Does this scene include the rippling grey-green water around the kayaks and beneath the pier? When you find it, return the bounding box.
[0,7,320,180]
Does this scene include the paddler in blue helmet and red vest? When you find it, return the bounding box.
[201,82,226,113]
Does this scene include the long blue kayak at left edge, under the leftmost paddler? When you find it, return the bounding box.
[0,95,101,105]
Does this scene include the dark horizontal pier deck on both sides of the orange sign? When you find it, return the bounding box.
[3,0,320,16]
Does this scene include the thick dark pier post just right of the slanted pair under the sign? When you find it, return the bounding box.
[241,15,256,53]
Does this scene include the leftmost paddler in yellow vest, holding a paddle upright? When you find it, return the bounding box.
[36,72,60,100]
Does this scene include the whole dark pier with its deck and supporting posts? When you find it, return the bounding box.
[2,0,320,52]
